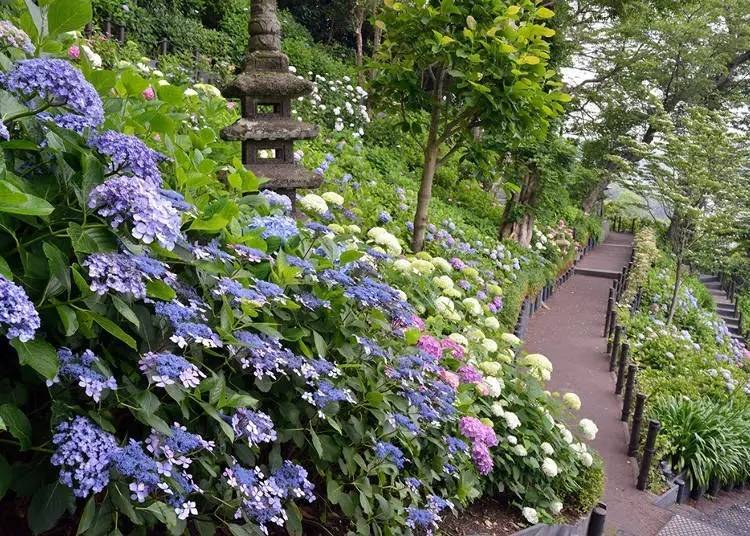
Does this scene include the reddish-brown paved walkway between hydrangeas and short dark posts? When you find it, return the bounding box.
[526,233,672,536]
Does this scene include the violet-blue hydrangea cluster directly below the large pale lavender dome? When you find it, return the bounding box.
[83,253,168,299]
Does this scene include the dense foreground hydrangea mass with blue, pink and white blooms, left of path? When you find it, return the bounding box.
[0,5,604,535]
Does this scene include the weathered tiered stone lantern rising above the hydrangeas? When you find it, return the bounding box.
[221,0,323,203]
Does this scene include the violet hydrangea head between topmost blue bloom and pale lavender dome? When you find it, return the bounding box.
[88,130,168,187]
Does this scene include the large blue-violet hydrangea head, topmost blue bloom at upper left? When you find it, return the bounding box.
[2,58,104,133]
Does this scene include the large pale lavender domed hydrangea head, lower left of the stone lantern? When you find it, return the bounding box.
[88,175,183,251]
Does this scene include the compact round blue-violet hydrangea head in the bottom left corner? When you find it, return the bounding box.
[50,416,117,498]
